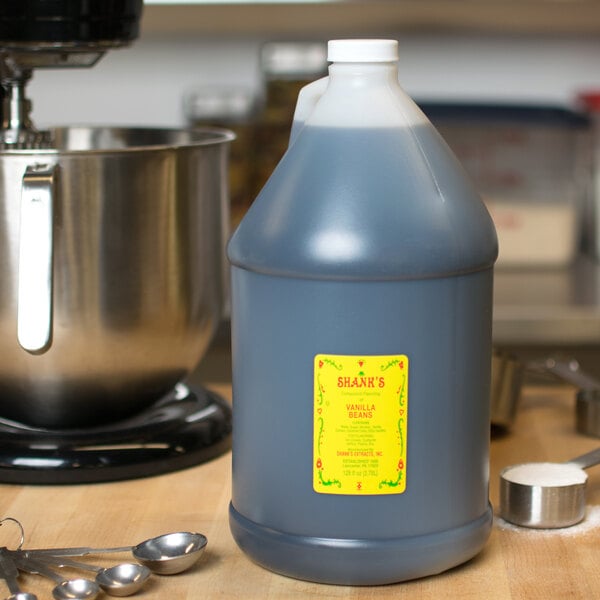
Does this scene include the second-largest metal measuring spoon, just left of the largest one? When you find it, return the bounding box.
[24,552,151,596]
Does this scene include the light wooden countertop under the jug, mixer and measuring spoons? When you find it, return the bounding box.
[0,386,600,600]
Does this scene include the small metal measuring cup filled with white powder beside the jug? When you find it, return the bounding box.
[500,448,600,529]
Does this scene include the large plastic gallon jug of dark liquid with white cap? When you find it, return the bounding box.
[228,40,497,585]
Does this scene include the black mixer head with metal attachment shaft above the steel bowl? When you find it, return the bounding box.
[0,0,143,149]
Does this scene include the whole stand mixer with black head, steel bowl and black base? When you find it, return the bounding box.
[0,0,233,483]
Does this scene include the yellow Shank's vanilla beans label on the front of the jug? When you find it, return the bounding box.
[313,354,408,495]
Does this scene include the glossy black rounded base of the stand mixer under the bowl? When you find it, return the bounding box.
[0,384,231,485]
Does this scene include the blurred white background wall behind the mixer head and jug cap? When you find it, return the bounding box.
[29,34,600,126]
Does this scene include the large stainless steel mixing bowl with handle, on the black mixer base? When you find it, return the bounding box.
[0,127,233,428]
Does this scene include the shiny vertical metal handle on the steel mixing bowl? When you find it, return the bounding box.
[17,164,57,354]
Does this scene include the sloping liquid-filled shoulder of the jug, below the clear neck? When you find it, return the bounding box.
[228,125,498,279]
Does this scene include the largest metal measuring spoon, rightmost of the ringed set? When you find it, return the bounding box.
[27,531,208,575]
